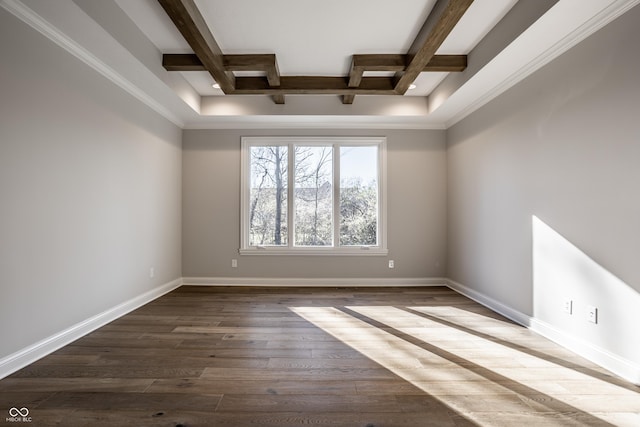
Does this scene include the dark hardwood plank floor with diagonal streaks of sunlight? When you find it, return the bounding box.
[0,286,640,427]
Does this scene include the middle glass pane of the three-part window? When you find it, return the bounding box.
[294,146,333,246]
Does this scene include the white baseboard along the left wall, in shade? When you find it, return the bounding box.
[0,279,182,379]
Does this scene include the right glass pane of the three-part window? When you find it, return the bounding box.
[340,146,378,246]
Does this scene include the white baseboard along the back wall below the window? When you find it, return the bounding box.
[182,277,447,288]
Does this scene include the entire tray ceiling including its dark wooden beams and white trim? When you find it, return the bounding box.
[0,0,640,129]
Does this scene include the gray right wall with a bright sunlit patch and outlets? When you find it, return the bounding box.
[447,7,640,363]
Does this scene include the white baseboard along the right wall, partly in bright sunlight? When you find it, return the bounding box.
[447,280,640,385]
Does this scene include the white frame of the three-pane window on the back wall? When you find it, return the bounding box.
[239,136,389,256]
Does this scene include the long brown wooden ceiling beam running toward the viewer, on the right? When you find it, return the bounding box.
[395,0,473,94]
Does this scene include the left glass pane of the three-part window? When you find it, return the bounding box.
[249,145,288,246]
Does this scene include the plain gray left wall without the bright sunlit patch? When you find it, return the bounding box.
[0,10,181,358]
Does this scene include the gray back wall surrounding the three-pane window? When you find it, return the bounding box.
[182,130,446,278]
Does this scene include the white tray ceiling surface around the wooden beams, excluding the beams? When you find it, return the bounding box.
[6,0,640,129]
